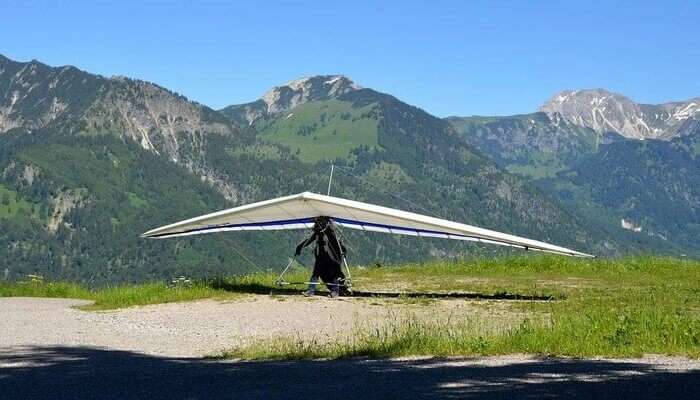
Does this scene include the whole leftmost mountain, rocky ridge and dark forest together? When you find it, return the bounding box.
[0,57,289,284]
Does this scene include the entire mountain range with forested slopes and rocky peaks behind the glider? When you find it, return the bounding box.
[0,56,700,284]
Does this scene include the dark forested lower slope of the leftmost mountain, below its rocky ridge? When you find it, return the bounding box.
[0,132,286,283]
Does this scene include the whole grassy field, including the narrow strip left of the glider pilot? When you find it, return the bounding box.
[0,256,700,359]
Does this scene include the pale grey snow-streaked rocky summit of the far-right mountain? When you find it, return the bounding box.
[540,89,700,140]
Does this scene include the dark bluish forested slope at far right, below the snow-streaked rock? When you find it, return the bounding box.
[538,131,700,254]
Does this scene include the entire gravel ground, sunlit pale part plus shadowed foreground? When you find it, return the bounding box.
[0,296,700,399]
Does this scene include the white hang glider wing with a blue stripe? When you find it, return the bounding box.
[141,192,593,257]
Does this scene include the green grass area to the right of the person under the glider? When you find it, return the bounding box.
[218,257,700,359]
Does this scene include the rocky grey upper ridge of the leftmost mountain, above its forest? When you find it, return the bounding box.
[0,56,237,161]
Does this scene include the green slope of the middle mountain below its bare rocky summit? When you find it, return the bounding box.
[223,85,644,254]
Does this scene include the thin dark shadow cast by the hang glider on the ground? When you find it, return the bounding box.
[210,280,564,301]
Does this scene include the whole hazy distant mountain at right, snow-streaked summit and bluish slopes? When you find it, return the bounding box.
[448,89,700,254]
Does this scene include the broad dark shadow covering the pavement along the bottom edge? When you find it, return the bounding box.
[0,347,700,400]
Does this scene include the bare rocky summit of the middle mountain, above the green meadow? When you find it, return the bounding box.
[221,75,361,125]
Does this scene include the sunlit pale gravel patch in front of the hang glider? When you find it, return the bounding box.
[0,295,525,357]
